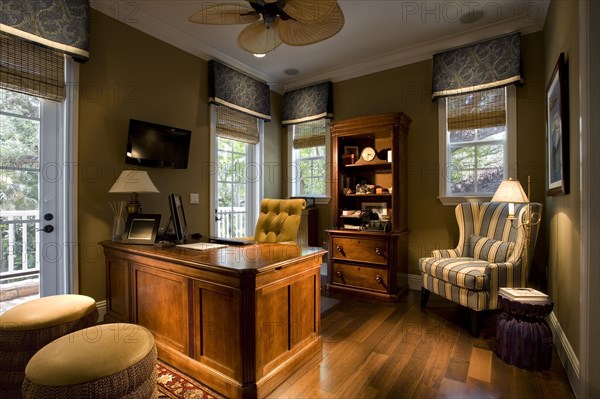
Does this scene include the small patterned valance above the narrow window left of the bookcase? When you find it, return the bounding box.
[282,82,333,125]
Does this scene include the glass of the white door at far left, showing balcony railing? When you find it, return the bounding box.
[0,89,42,313]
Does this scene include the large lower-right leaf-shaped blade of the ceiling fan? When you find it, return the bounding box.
[279,3,344,46]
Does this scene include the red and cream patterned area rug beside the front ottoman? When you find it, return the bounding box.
[156,360,225,399]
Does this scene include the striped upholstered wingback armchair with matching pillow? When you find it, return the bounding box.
[419,202,542,336]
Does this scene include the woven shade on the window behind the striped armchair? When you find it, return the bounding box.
[446,88,506,131]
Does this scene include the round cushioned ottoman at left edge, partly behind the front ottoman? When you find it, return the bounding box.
[0,295,98,398]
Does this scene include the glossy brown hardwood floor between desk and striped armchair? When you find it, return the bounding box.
[269,291,575,398]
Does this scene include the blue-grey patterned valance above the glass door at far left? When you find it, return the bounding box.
[0,0,90,61]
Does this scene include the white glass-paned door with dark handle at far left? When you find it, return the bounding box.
[0,89,71,312]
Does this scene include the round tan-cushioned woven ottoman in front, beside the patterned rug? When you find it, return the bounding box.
[22,323,158,399]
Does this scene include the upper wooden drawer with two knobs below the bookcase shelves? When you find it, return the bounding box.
[331,237,389,265]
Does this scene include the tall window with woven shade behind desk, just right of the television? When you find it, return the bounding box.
[210,105,264,238]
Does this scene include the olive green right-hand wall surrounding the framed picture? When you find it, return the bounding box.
[544,0,581,356]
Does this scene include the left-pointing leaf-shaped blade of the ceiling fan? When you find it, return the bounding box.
[189,3,260,25]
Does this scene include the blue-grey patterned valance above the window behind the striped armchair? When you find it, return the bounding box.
[432,33,522,98]
